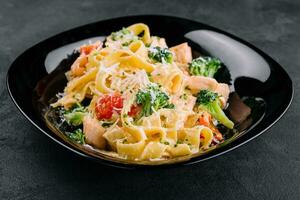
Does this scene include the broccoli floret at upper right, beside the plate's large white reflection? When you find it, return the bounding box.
[189,57,221,78]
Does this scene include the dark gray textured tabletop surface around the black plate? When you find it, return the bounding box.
[0,0,300,200]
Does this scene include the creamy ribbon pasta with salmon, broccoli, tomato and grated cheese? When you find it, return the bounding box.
[51,23,234,161]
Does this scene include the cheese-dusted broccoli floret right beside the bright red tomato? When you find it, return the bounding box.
[136,84,174,117]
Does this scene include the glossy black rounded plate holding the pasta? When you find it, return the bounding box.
[7,15,293,168]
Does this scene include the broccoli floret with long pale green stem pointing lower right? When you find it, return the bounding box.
[196,90,234,129]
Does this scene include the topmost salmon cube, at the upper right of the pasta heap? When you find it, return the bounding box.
[170,42,193,64]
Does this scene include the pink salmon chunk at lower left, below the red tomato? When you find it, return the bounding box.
[83,116,106,149]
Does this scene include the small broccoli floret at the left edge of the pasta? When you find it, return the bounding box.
[63,104,87,126]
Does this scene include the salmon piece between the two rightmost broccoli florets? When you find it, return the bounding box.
[187,76,218,94]
